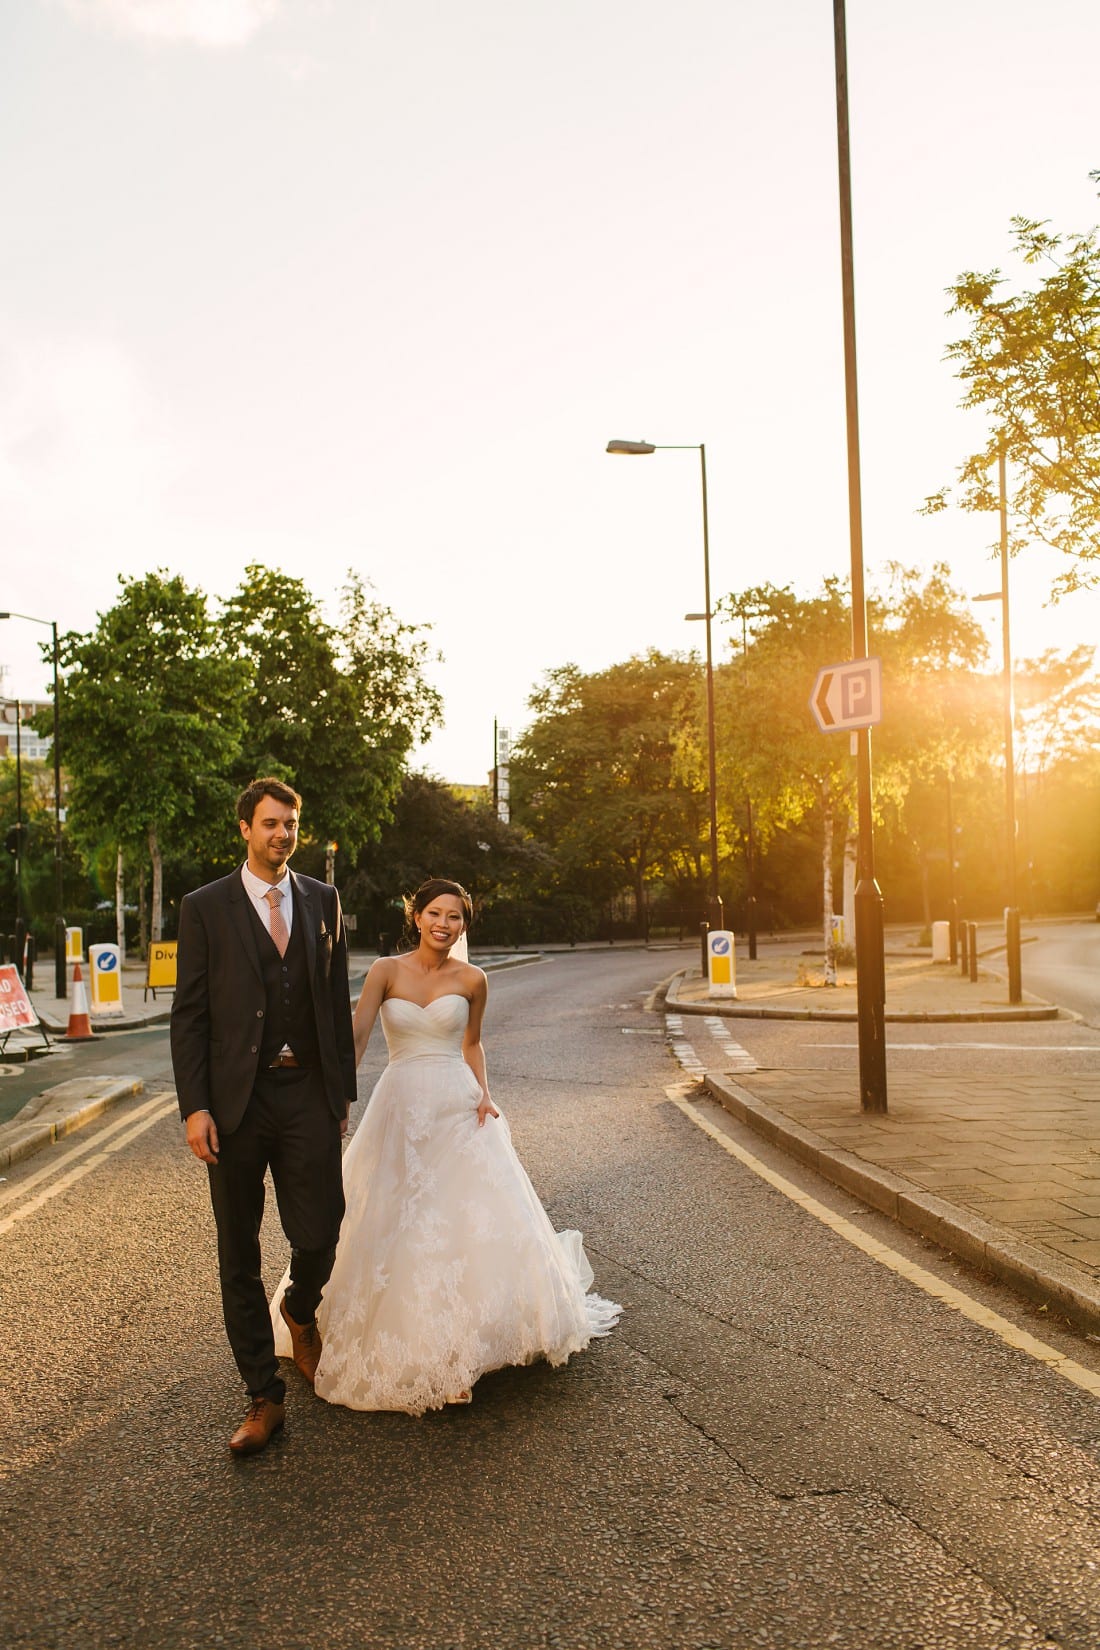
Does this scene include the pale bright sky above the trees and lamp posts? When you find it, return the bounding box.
[0,0,1100,784]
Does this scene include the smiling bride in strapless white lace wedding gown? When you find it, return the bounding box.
[272,878,622,1416]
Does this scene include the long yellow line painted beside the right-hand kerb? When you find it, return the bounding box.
[665,1089,1100,1398]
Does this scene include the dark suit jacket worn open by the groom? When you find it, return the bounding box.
[172,870,355,1134]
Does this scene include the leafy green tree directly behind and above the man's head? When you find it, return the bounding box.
[223,564,442,856]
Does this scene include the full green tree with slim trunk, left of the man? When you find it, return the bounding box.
[58,569,247,941]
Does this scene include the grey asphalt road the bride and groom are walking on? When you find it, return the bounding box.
[0,952,1100,1650]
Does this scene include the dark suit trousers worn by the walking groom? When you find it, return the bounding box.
[208,1068,343,1403]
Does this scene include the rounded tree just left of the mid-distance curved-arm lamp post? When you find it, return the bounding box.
[511,650,706,922]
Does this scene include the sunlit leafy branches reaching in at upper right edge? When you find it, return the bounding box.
[925,218,1100,594]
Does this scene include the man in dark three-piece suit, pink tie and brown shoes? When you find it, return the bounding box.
[172,779,355,1455]
